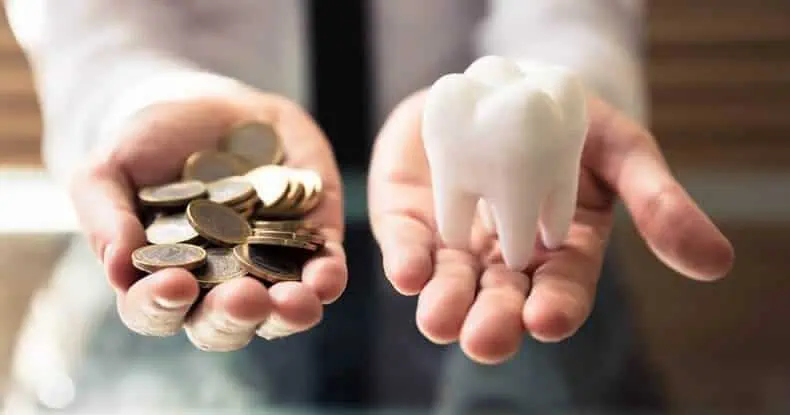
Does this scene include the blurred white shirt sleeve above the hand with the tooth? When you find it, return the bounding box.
[477,0,647,122]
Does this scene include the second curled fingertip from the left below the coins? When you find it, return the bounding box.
[185,277,272,352]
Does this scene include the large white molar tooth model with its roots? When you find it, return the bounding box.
[422,56,587,271]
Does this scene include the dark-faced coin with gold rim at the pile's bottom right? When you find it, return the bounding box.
[233,244,302,282]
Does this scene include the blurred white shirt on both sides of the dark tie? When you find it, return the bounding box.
[5,0,645,181]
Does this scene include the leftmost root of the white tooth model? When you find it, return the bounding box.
[433,185,479,249]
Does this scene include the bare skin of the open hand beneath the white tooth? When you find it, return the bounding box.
[368,92,734,364]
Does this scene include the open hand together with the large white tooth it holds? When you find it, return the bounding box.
[368,56,733,363]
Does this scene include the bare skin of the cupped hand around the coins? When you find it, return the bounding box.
[70,90,348,351]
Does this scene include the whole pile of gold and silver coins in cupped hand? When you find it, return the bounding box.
[132,123,325,290]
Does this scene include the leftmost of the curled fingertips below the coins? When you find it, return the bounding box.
[118,268,204,336]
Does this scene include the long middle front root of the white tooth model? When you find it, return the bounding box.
[492,185,542,271]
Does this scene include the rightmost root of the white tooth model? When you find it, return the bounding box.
[540,174,579,249]
